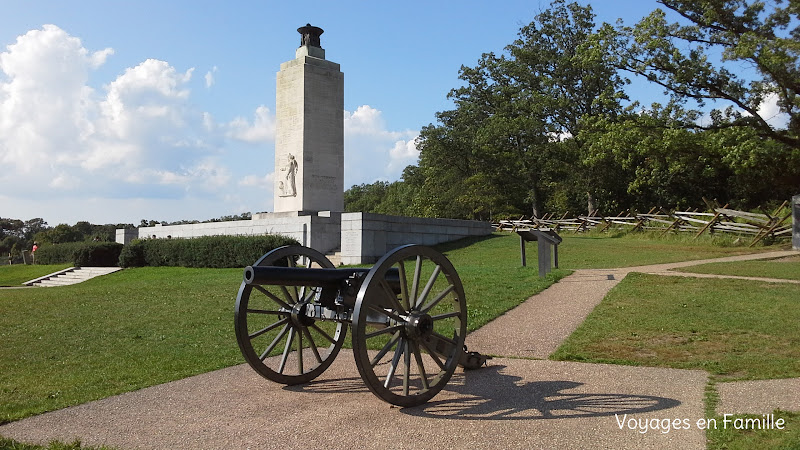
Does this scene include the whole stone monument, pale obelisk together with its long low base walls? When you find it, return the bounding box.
[117,24,492,264]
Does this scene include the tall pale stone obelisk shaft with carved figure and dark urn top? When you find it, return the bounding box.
[274,24,344,212]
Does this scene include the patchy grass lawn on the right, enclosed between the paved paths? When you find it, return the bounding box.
[553,274,800,381]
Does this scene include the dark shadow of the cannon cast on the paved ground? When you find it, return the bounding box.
[284,365,681,420]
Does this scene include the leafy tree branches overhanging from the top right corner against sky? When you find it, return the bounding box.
[606,0,800,149]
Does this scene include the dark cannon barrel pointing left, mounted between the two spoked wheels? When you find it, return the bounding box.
[244,266,400,292]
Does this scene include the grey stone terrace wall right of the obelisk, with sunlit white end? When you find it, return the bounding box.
[341,212,492,264]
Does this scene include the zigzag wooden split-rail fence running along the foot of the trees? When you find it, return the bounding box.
[494,202,792,247]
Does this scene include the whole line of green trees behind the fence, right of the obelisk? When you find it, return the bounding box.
[345,0,800,219]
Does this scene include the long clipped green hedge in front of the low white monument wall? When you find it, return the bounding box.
[119,235,298,268]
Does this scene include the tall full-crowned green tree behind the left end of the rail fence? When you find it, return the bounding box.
[410,0,625,218]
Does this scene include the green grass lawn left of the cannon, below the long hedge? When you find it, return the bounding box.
[0,268,241,421]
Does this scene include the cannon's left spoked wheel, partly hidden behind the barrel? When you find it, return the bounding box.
[234,245,347,385]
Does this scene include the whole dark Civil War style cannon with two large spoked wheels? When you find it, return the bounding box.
[234,245,486,406]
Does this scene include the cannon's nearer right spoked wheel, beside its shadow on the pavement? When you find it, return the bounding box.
[352,245,467,406]
